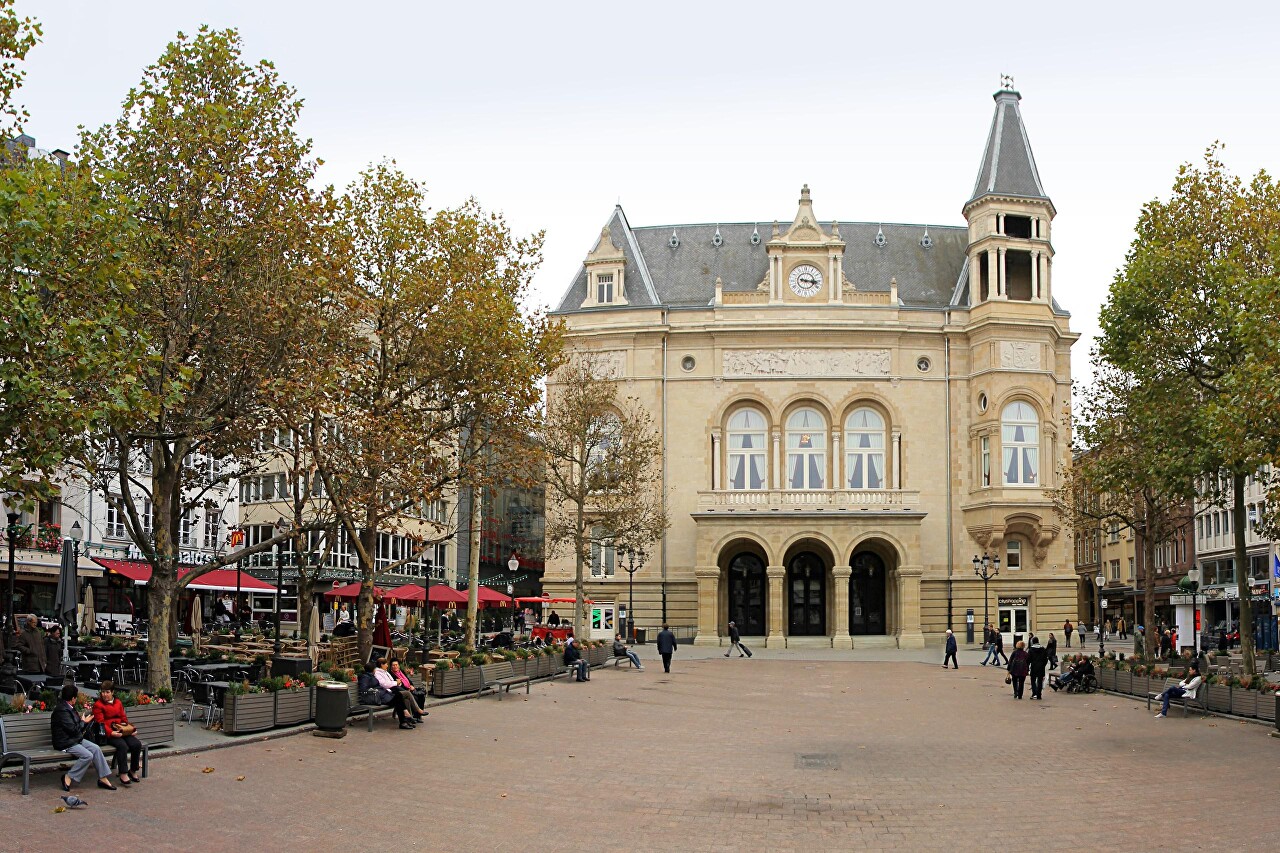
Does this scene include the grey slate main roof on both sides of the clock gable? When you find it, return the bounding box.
[556,207,969,314]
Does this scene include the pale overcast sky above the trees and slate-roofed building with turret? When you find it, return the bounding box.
[17,0,1280,378]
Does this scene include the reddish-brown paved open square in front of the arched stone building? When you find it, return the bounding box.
[0,653,1280,852]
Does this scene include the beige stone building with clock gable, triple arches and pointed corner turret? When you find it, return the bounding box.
[544,88,1078,648]
